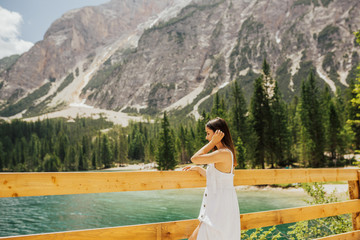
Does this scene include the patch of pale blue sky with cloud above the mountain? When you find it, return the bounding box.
[0,0,109,59]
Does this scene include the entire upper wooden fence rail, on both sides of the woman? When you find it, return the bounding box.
[0,168,357,197]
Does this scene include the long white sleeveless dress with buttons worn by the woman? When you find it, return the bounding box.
[197,149,241,240]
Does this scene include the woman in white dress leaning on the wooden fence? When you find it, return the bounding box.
[184,118,240,240]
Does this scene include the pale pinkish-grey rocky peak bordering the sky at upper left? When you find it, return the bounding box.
[0,0,183,105]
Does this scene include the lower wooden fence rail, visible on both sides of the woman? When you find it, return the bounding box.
[0,200,360,240]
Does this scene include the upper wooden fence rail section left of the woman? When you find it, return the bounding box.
[0,171,206,197]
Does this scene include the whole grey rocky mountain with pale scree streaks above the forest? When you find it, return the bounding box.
[0,0,360,119]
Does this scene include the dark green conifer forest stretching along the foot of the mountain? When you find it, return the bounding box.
[0,60,360,171]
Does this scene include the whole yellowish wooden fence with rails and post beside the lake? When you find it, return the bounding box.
[0,169,360,240]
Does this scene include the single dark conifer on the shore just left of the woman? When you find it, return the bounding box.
[156,111,176,170]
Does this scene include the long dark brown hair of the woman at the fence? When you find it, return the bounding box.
[206,117,237,166]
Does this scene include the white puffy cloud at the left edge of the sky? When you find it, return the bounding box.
[0,7,34,58]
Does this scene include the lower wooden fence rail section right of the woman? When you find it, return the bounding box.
[240,199,360,230]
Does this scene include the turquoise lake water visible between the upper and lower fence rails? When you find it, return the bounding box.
[0,188,306,236]
